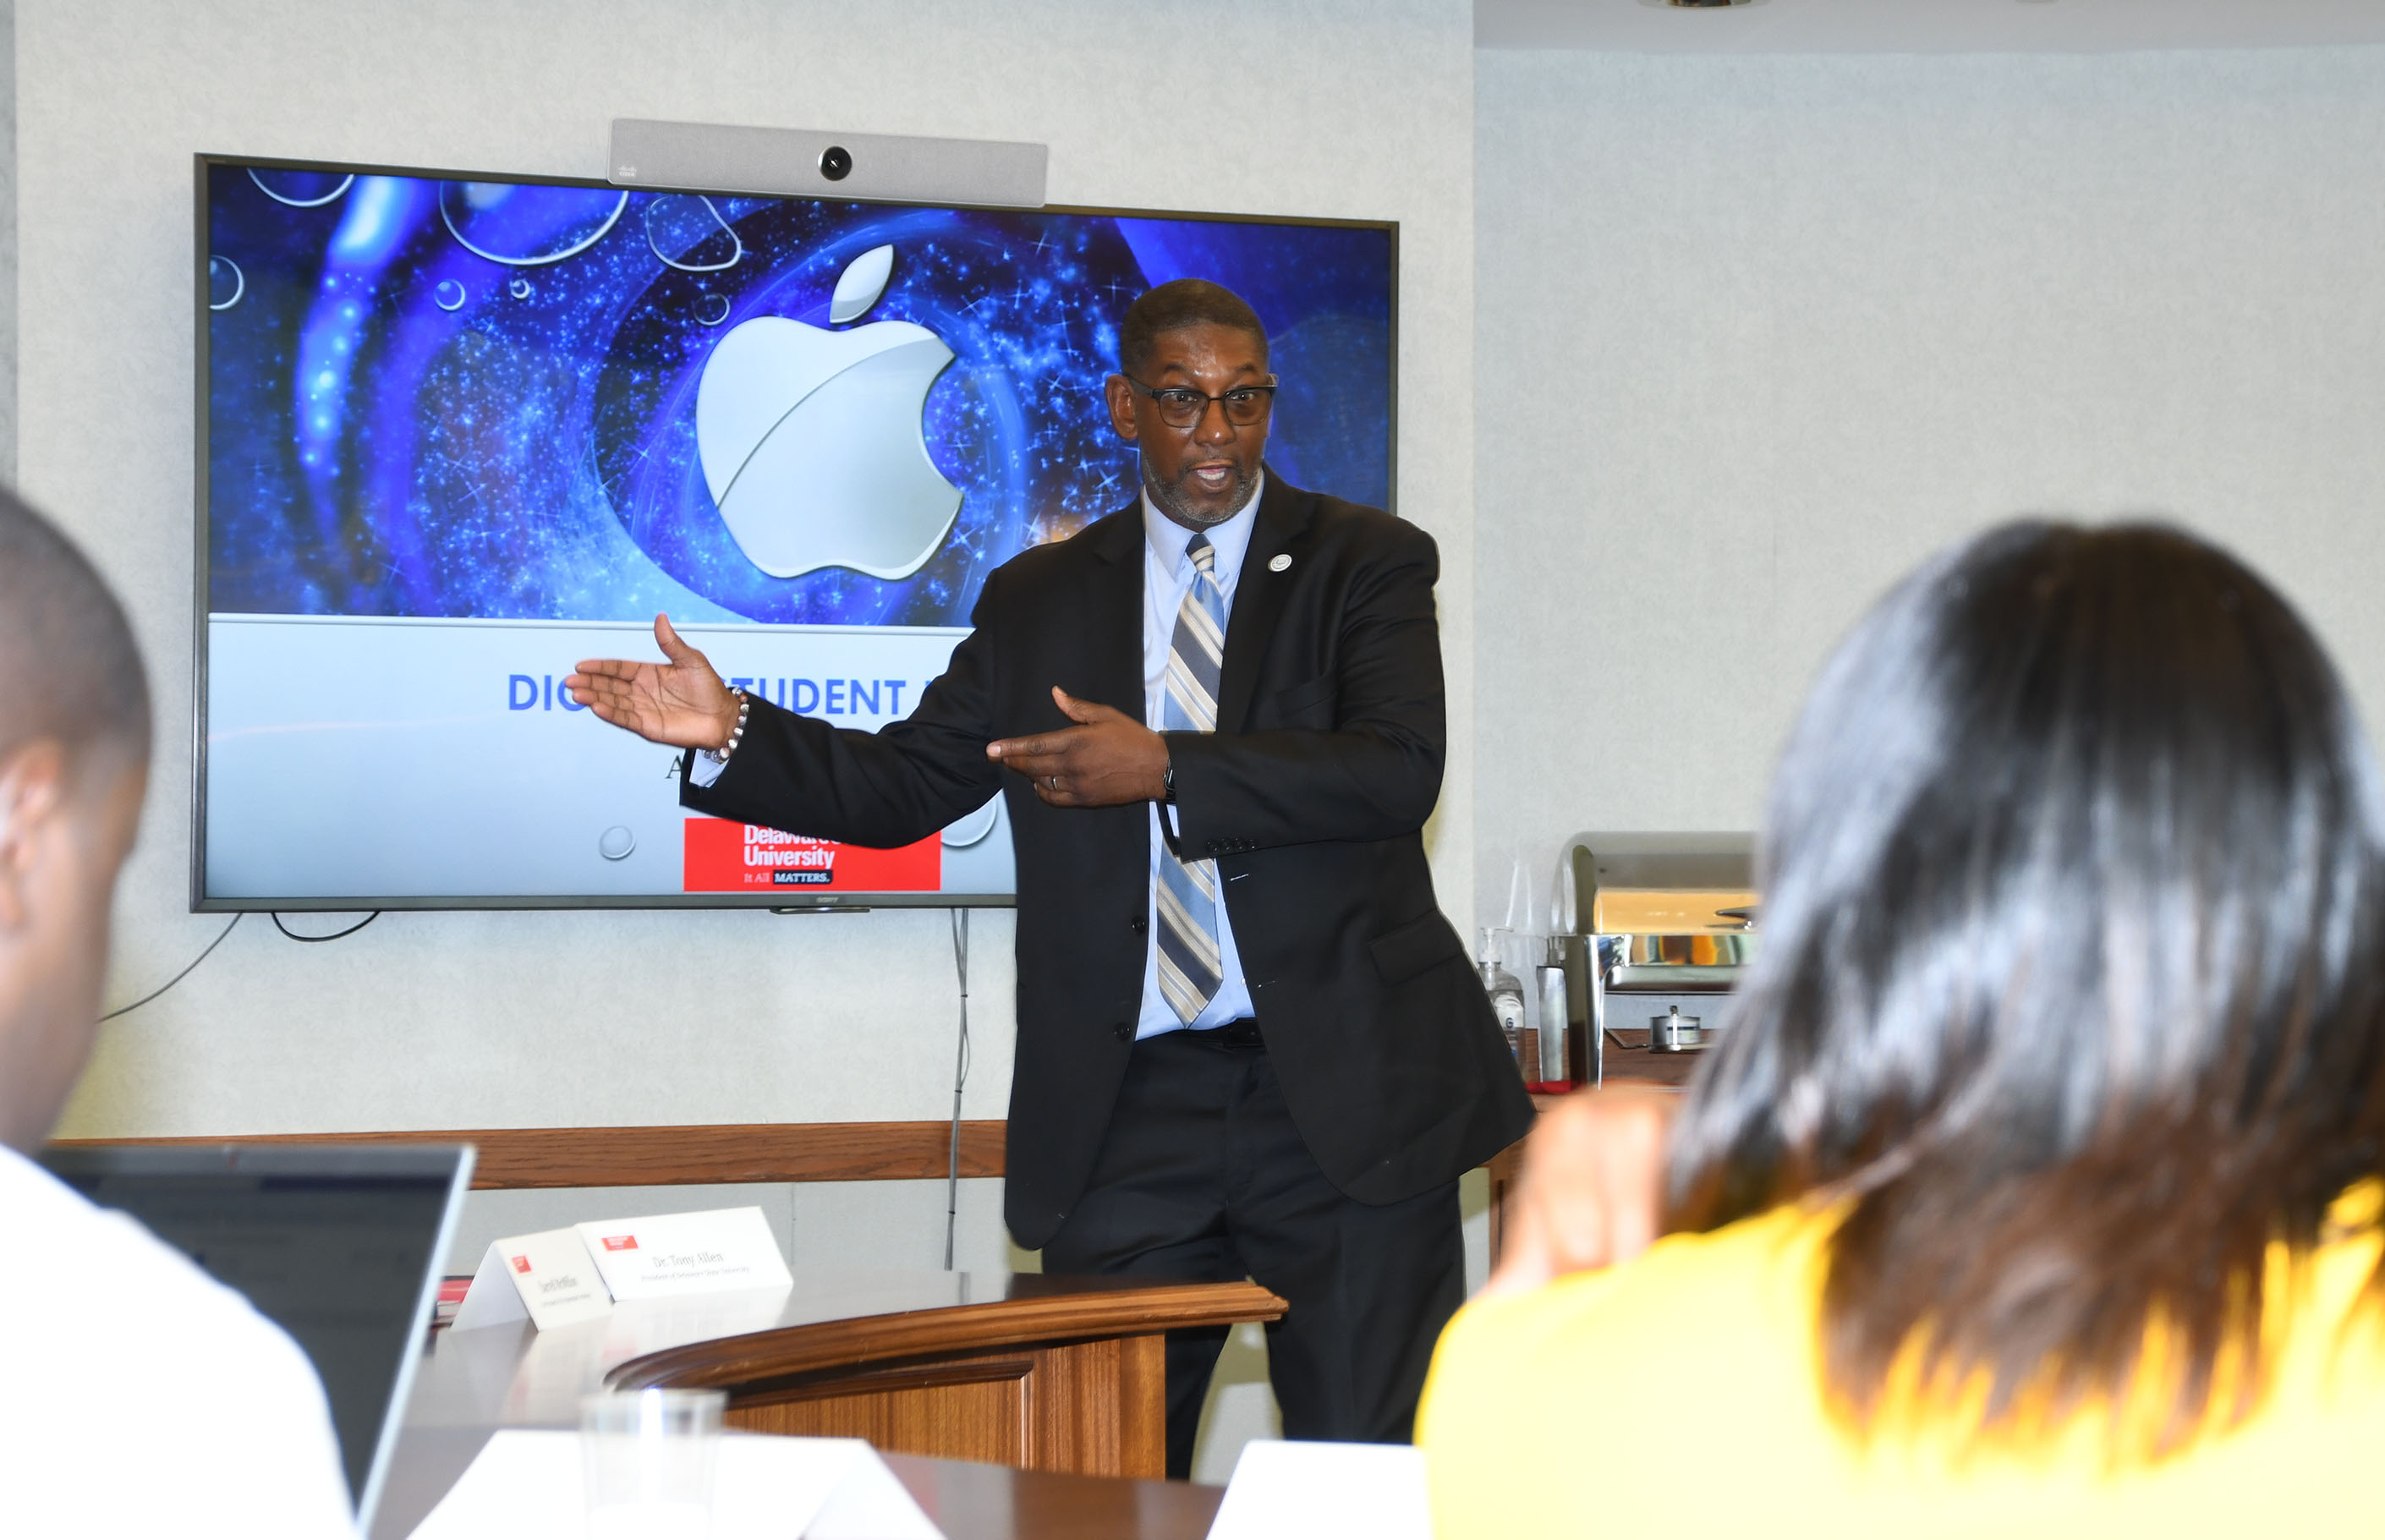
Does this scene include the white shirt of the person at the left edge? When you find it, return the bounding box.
[0,1149,353,1535]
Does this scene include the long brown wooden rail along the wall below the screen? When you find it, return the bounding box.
[58,1118,1004,1187]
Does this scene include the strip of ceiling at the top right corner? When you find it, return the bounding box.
[1474,0,2385,52]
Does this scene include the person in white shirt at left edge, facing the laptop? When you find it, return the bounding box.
[0,491,355,1540]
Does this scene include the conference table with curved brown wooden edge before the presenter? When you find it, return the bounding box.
[372,1269,1286,1540]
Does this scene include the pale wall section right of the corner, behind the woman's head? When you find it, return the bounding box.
[1474,47,2385,923]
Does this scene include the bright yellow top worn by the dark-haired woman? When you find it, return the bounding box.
[1417,1206,2385,1540]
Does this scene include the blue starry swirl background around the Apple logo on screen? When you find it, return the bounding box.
[207,165,1393,627]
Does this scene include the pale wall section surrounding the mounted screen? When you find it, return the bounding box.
[17,0,1474,1135]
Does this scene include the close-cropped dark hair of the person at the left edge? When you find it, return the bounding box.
[0,491,151,772]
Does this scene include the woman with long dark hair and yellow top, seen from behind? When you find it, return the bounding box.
[1419,522,2385,1540]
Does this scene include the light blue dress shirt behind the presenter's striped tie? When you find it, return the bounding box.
[1135,472,1266,1042]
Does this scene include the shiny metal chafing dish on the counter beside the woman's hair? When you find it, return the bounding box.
[1553,832,1757,1085]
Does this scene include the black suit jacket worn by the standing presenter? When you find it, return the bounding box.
[680,474,1531,1247]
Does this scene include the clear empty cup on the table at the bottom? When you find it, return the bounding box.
[579,1389,730,1540]
